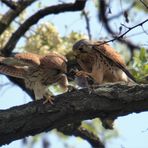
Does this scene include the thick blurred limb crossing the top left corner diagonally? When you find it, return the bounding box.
[0,0,36,35]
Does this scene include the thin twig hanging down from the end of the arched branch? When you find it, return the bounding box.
[82,10,92,40]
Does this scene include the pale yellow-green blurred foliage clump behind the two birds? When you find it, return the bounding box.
[23,23,86,56]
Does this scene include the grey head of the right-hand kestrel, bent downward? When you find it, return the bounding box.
[72,39,92,55]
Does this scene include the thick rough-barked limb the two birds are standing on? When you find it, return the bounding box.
[0,84,148,145]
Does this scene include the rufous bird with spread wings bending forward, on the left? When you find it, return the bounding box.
[0,52,68,103]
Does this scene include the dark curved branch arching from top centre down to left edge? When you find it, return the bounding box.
[1,0,86,55]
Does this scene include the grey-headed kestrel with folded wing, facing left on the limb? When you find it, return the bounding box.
[73,39,135,84]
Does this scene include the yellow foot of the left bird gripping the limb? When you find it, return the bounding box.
[43,90,54,104]
